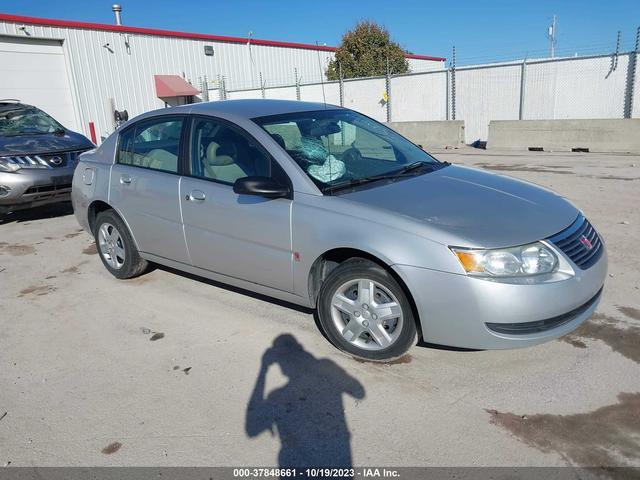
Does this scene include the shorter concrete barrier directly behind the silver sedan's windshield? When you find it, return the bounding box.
[387,120,464,148]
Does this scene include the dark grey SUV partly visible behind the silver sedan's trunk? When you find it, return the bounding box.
[0,100,94,215]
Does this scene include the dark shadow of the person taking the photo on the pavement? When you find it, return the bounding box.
[245,335,365,468]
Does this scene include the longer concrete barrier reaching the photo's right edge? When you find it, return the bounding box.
[487,119,640,153]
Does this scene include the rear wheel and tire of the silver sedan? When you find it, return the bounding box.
[93,210,149,279]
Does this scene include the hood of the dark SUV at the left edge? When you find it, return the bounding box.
[0,131,95,156]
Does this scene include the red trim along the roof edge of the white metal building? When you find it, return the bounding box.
[0,13,445,62]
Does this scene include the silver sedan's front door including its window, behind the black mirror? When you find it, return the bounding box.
[180,117,293,292]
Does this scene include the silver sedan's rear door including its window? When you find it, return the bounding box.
[109,115,189,264]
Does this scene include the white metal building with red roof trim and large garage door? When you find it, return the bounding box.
[0,14,445,142]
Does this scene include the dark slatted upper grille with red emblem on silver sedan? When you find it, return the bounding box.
[547,215,603,270]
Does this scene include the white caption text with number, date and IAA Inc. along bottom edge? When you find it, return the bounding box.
[233,467,400,479]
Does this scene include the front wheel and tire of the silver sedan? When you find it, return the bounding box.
[318,258,418,362]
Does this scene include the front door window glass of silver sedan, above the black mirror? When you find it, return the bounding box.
[191,118,286,184]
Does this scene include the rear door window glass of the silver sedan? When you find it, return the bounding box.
[118,118,182,173]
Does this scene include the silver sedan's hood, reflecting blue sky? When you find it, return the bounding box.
[340,165,579,248]
